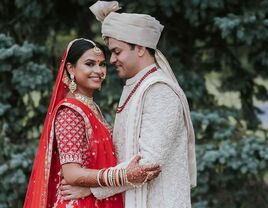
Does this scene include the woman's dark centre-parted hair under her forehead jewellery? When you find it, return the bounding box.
[66,39,106,65]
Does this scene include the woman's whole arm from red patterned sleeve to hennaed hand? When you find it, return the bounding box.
[55,107,159,200]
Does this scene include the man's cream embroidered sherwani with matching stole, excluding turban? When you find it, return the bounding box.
[91,65,191,208]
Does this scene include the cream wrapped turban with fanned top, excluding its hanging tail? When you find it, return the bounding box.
[90,1,164,49]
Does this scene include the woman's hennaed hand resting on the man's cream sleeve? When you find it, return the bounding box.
[127,155,161,184]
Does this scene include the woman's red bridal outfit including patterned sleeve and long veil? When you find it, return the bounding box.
[24,46,123,208]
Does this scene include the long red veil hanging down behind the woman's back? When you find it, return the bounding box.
[24,44,69,208]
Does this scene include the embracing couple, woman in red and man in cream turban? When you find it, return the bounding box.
[24,1,196,208]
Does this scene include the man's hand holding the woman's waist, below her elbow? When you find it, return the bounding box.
[60,179,91,200]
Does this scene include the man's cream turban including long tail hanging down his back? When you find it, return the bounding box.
[90,1,197,186]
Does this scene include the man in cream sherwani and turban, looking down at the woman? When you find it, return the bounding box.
[61,1,196,208]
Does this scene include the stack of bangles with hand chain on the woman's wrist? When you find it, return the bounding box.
[97,168,148,188]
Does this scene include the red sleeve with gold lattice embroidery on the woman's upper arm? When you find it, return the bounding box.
[55,107,86,165]
